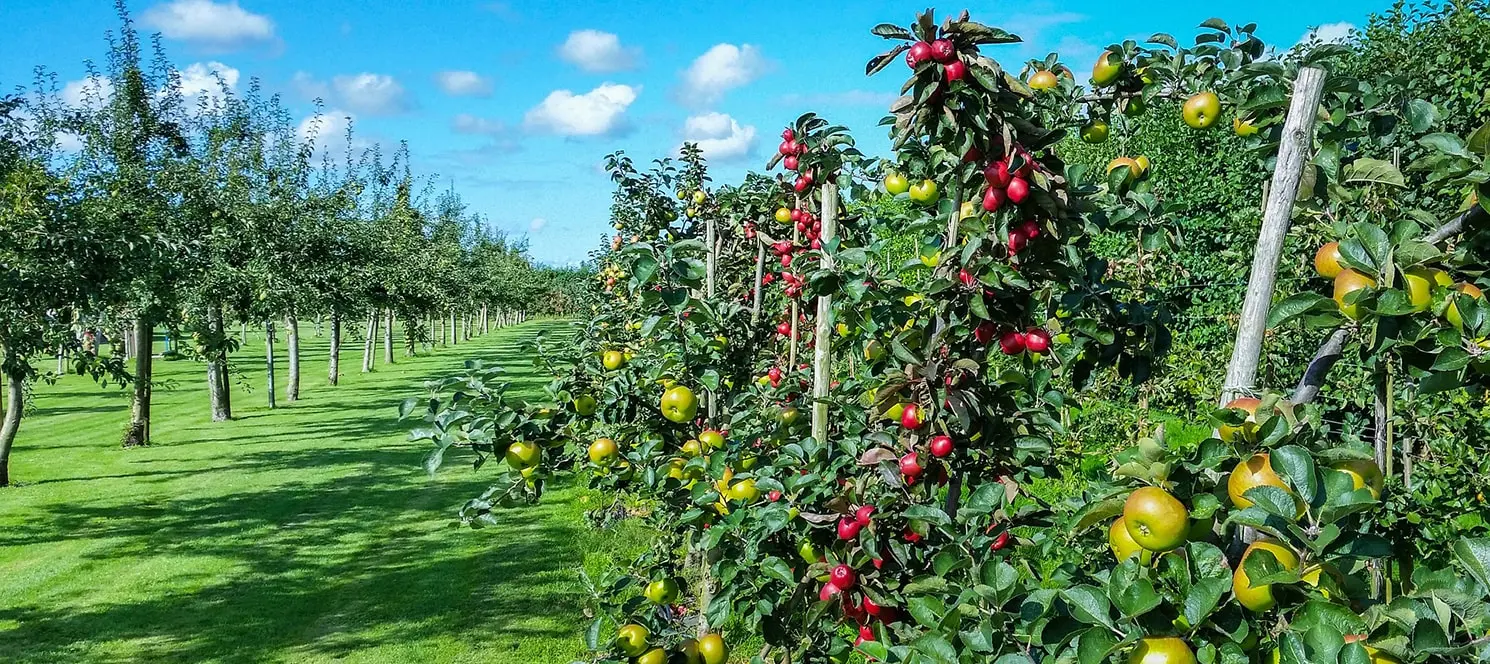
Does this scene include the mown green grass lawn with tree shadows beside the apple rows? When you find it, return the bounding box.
[0,322,647,664]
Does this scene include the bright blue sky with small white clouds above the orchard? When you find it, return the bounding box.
[0,0,1390,264]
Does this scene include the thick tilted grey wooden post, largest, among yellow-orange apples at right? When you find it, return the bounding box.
[1220,67,1325,405]
